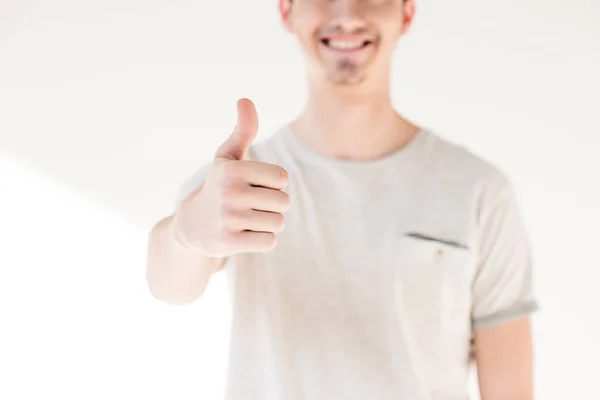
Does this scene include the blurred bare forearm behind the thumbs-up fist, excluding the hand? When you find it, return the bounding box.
[146,217,224,304]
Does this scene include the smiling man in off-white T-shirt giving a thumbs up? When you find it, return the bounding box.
[148,0,536,400]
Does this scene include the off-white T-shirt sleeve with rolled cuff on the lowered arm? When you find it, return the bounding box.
[472,180,539,331]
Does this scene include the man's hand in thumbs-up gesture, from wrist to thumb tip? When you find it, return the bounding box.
[174,99,290,257]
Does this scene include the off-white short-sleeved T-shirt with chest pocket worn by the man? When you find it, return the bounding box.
[179,127,537,400]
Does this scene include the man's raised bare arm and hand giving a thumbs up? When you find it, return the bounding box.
[146,99,289,304]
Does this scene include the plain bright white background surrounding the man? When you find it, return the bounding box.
[0,0,600,400]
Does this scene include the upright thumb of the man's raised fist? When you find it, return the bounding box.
[216,99,258,160]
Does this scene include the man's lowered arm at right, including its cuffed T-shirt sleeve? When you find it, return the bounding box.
[473,177,538,400]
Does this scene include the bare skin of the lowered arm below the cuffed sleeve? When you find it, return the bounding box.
[475,317,533,400]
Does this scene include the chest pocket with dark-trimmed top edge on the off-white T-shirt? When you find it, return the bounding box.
[392,235,474,336]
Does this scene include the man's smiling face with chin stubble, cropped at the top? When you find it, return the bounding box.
[280,0,414,85]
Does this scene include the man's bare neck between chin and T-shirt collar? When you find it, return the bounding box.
[290,76,419,161]
